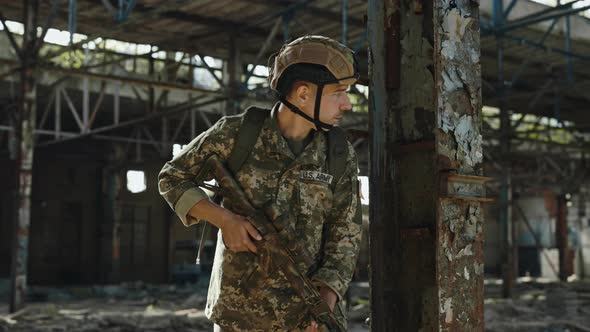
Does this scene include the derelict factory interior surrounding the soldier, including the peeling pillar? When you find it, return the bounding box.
[0,0,590,332]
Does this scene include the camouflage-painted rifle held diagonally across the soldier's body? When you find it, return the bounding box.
[198,154,346,332]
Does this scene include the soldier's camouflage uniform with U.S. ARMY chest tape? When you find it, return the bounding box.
[159,106,361,331]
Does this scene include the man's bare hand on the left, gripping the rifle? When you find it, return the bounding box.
[219,210,262,253]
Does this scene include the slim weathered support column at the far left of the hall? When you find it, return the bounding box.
[10,0,39,312]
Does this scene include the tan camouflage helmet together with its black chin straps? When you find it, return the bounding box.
[268,36,359,130]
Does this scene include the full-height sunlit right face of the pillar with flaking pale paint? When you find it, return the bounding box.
[434,0,485,331]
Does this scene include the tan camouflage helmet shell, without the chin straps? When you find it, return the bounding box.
[269,36,359,94]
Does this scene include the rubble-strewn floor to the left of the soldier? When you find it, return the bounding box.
[0,282,212,332]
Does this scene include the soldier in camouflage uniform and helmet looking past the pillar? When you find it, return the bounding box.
[159,36,361,331]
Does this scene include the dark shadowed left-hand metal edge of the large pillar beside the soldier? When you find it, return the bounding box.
[367,0,403,331]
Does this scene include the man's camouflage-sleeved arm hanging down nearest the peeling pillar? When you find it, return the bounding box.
[312,143,362,300]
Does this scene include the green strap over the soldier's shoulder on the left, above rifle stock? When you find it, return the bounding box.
[227,106,270,175]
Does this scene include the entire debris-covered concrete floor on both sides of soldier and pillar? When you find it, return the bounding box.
[0,280,590,332]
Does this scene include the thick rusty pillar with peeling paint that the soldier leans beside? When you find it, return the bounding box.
[368,0,490,332]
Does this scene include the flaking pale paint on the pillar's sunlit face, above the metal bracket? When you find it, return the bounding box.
[435,0,483,175]
